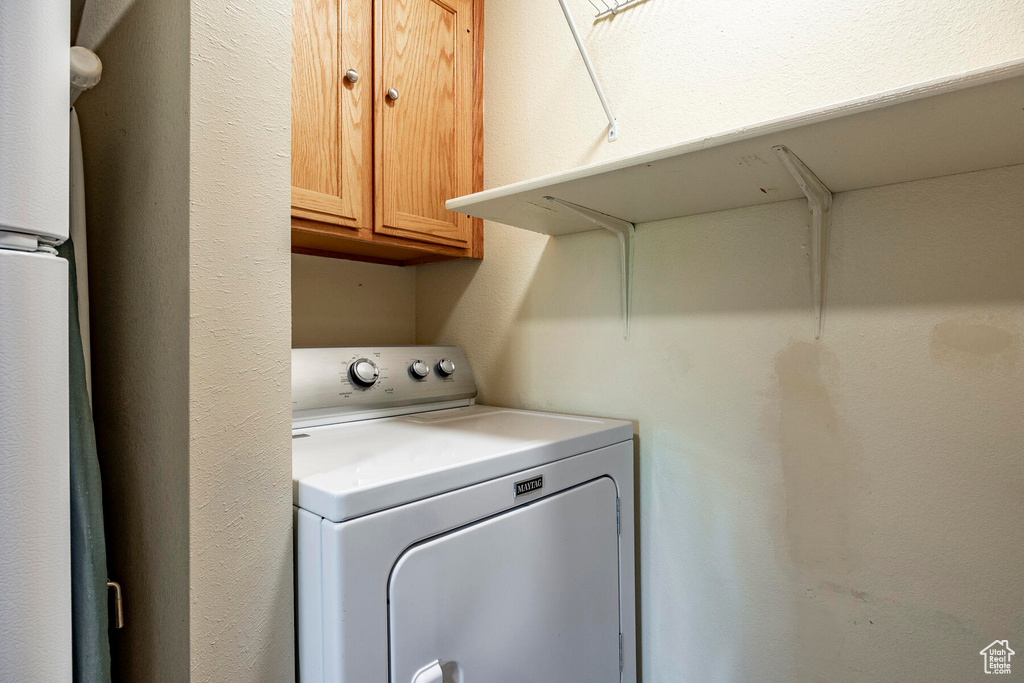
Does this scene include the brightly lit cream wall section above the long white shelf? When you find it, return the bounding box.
[484,0,1024,187]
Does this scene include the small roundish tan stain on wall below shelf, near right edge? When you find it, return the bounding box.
[931,319,1021,373]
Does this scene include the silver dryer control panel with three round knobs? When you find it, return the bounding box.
[292,346,476,427]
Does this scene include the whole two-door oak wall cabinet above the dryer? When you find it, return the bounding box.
[292,0,483,265]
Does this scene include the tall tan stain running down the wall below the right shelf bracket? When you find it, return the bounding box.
[762,340,867,680]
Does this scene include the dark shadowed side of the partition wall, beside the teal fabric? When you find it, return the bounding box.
[76,0,189,682]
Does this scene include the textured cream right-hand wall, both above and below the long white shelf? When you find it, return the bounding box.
[416,0,1024,683]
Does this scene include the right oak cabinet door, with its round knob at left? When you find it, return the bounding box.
[375,0,475,247]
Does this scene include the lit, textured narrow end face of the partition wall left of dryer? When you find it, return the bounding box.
[188,0,295,683]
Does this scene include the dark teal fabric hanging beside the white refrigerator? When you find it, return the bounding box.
[57,240,111,683]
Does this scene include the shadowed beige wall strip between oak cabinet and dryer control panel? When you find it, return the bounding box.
[292,254,416,347]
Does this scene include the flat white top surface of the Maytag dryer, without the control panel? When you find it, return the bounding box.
[292,405,633,522]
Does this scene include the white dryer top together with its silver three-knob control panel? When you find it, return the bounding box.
[292,346,633,522]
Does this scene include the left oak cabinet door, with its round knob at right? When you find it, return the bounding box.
[292,0,374,228]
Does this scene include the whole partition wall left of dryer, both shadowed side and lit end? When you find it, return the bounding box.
[79,0,294,683]
